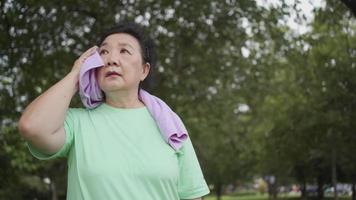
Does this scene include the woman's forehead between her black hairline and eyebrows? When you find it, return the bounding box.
[100,33,140,49]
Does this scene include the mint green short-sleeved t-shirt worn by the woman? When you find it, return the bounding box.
[29,104,209,200]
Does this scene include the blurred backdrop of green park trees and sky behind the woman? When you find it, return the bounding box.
[0,0,356,200]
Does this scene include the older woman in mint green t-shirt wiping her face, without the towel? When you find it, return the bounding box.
[19,23,209,200]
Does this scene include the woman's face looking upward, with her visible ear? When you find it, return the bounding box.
[97,33,150,93]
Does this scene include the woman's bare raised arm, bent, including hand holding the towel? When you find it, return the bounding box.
[19,46,98,154]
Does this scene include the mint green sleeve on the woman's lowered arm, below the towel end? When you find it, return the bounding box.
[178,137,210,199]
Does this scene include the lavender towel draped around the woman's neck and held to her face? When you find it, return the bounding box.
[79,52,188,150]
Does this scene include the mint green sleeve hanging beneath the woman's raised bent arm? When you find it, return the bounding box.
[27,108,75,160]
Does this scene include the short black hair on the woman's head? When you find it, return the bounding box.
[98,21,156,90]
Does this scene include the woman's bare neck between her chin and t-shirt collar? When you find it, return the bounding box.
[105,90,144,108]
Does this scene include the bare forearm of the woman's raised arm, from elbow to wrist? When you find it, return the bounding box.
[19,71,78,136]
